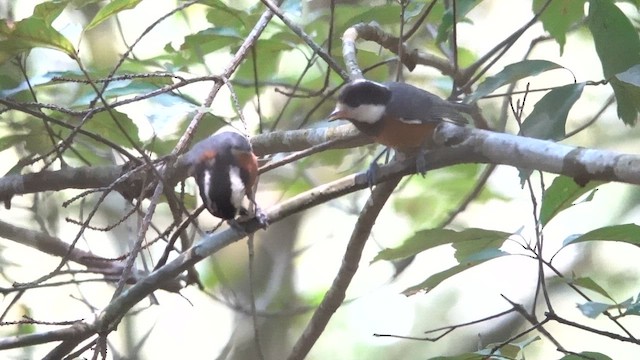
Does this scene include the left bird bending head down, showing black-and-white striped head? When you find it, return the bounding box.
[185,131,267,227]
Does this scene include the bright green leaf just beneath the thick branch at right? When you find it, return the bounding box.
[540,175,604,227]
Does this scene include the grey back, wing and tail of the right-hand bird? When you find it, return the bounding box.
[385,82,468,124]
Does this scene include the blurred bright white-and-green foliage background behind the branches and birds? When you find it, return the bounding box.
[0,0,640,359]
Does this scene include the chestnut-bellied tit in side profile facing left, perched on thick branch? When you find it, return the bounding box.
[329,79,468,152]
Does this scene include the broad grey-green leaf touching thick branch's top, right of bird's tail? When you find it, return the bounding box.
[520,82,585,140]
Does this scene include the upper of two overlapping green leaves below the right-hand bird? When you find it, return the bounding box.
[372,228,511,262]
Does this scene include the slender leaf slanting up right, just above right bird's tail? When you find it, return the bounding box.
[464,60,564,104]
